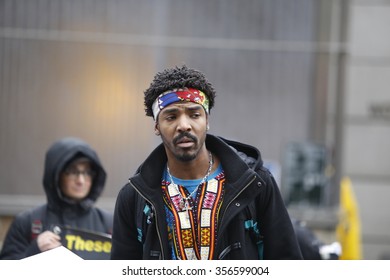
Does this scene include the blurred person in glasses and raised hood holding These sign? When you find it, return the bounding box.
[0,137,112,259]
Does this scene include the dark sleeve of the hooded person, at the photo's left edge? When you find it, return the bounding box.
[0,211,41,260]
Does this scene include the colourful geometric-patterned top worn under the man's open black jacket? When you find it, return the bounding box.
[162,166,225,260]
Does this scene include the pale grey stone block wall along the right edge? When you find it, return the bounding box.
[343,0,390,259]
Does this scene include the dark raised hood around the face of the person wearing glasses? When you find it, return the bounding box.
[43,137,106,210]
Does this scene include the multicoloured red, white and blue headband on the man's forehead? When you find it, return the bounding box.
[152,88,209,120]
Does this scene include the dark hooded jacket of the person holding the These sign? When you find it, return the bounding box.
[0,138,112,259]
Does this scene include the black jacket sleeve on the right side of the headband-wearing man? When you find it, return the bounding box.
[259,167,302,260]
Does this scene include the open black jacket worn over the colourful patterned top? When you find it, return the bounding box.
[111,135,302,260]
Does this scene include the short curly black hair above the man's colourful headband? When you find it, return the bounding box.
[144,65,215,117]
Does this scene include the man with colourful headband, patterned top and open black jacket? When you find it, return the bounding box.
[111,65,302,260]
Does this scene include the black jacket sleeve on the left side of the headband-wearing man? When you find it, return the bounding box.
[111,185,142,260]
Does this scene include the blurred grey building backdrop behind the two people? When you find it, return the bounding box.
[0,0,390,259]
